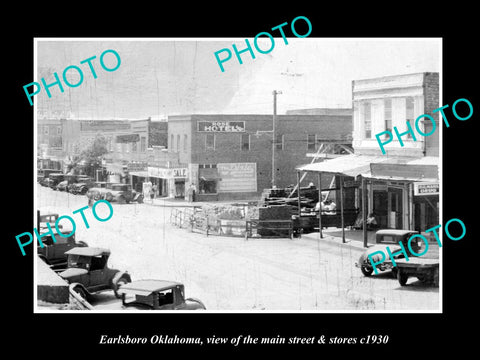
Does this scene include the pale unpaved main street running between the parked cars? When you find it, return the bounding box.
[37,185,440,311]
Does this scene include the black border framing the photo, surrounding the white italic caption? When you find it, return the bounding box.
[9,3,480,356]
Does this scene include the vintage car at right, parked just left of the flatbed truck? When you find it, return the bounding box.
[355,229,421,276]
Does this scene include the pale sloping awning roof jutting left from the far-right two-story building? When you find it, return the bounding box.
[297,154,387,177]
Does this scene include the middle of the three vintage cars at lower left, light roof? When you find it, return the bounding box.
[59,247,132,299]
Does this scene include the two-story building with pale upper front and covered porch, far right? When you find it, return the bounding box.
[298,72,440,231]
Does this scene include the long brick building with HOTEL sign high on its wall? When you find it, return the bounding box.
[168,109,352,200]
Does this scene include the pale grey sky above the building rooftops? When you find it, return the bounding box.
[35,37,441,120]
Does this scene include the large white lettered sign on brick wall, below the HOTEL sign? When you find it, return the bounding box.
[217,163,257,193]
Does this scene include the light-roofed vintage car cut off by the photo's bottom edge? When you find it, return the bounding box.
[118,280,206,310]
